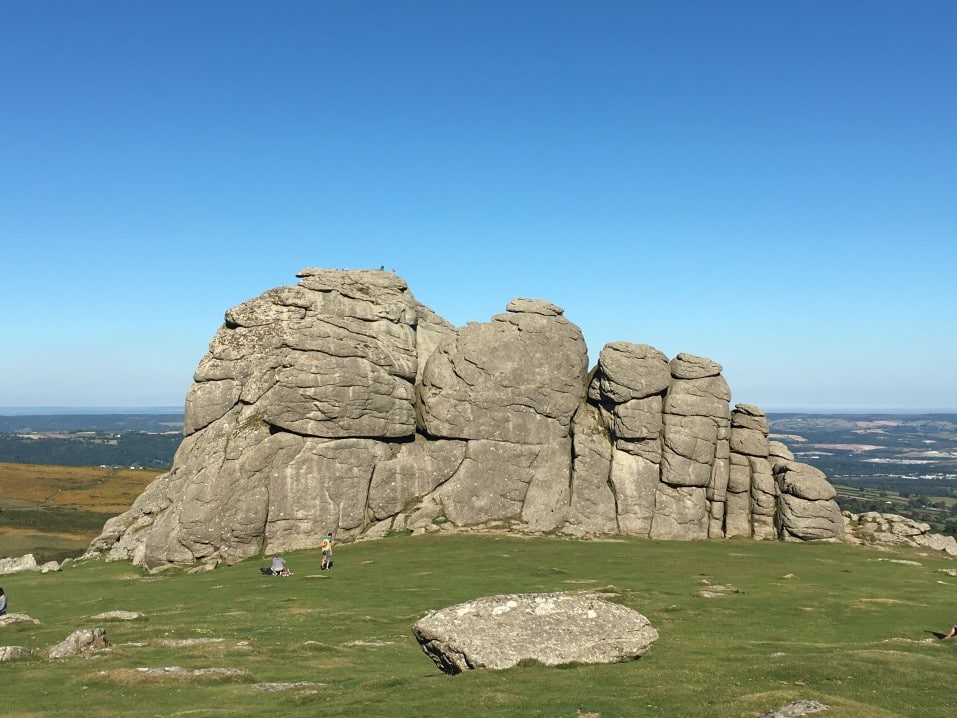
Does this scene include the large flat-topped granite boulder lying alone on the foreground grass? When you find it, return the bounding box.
[412,593,658,673]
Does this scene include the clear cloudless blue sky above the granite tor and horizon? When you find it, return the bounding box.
[0,0,957,411]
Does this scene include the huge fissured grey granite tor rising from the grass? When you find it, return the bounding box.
[88,269,844,570]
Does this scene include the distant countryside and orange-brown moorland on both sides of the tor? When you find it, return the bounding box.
[0,414,957,561]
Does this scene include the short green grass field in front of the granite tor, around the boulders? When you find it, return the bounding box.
[0,534,957,718]
